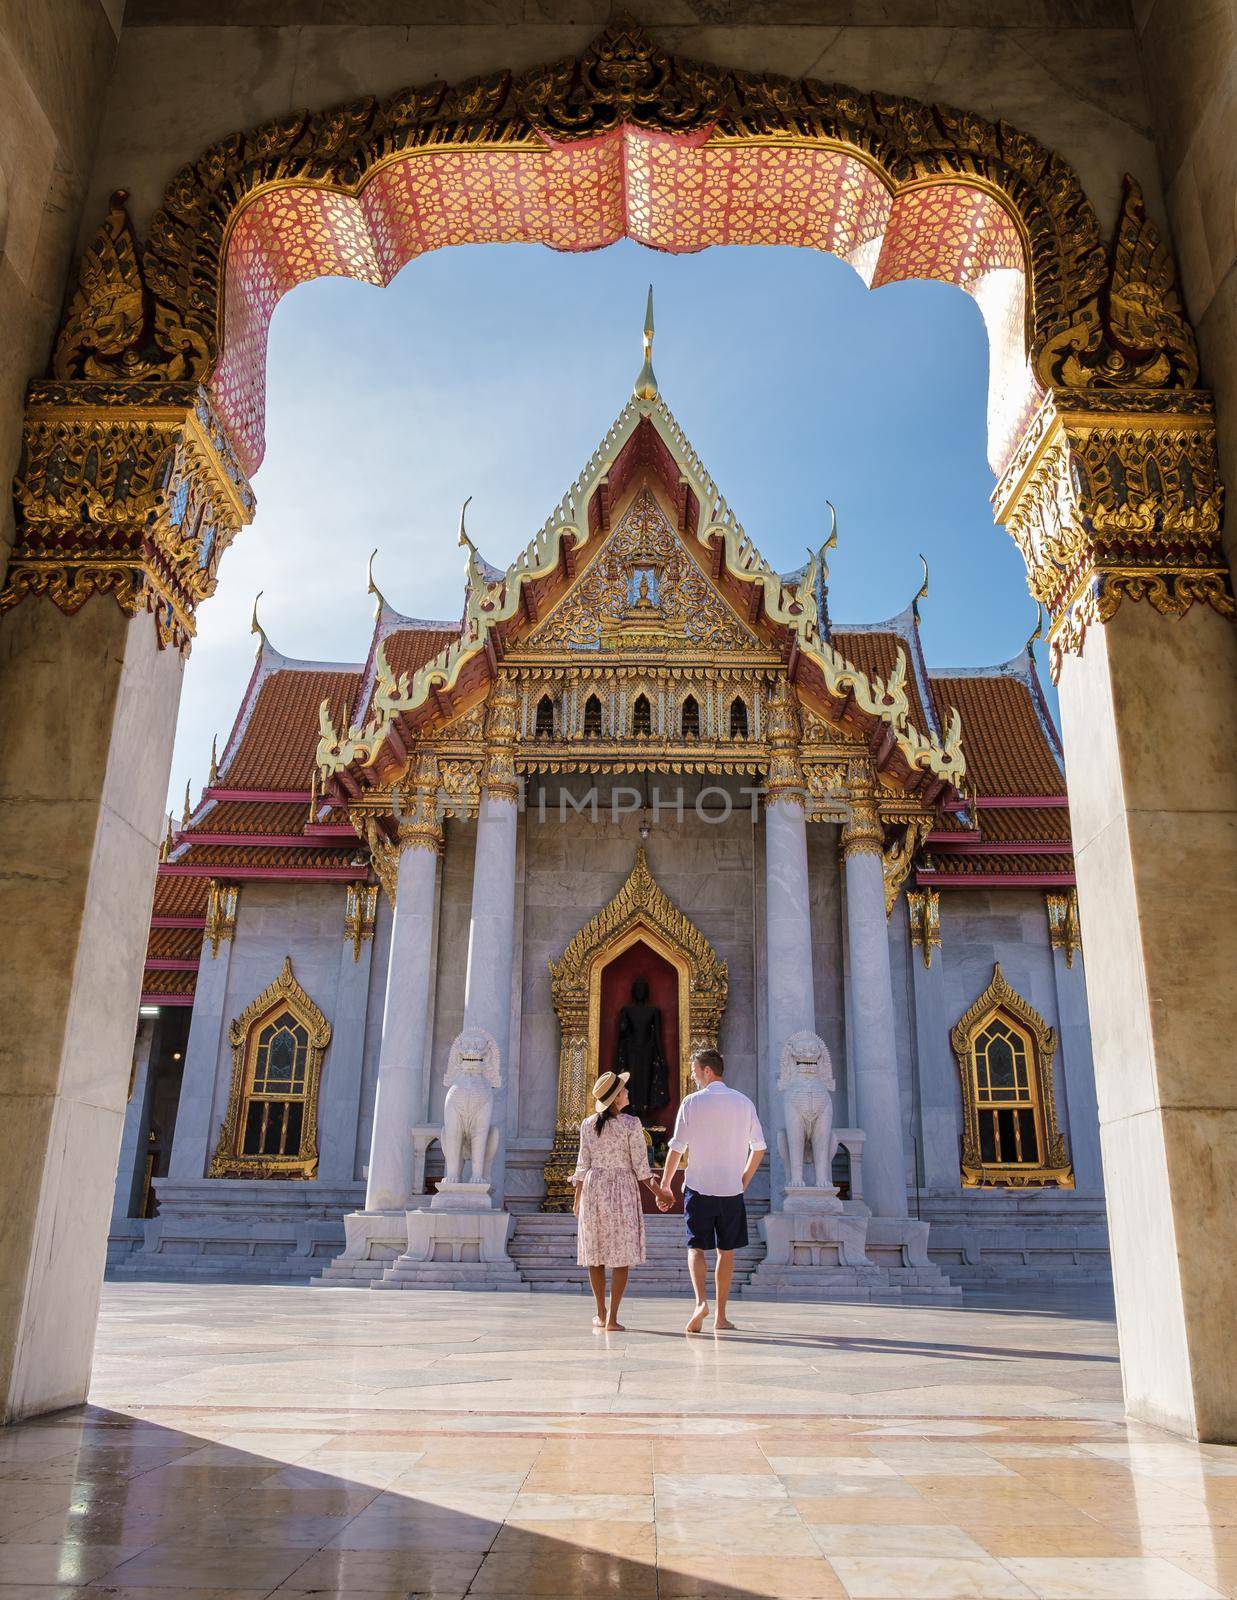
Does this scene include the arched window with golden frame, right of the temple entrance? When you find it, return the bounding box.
[951,963,1074,1189]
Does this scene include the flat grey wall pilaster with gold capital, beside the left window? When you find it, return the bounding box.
[318,883,379,1184]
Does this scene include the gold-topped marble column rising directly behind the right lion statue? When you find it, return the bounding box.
[760,678,816,1210]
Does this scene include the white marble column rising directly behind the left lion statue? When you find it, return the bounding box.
[464,789,520,1206]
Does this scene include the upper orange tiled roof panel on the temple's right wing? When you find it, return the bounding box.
[928,675,1066,800]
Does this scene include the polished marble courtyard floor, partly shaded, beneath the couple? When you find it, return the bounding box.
[0,1285,1237,1600]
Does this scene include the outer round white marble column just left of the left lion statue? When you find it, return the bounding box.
[365,830,440,1213]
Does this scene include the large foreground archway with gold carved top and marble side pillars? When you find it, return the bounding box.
[0,24,1237,1438]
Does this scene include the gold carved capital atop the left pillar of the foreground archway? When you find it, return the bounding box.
[0,381,254,651]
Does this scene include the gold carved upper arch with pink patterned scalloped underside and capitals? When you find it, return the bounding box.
[0,19,1234,669]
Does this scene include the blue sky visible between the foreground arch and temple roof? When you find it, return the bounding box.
[170,242,1034,816]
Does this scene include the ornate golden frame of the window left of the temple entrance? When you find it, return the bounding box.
[208,955,331,1178]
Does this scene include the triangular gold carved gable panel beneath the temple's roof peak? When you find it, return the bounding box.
[528,486,763,654]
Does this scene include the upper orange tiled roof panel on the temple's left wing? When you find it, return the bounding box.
[219,666,360,789]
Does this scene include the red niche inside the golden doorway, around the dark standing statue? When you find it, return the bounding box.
[597,936,687,1211]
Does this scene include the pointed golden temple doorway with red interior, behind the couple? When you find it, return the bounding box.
[542,846,728,1211]
